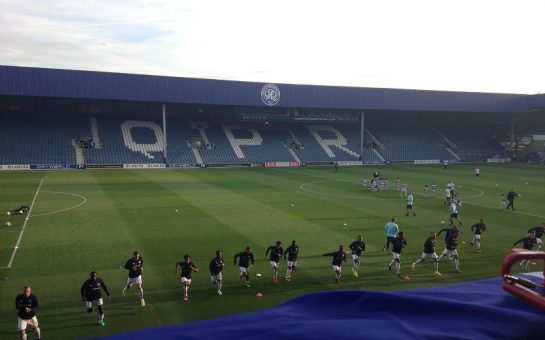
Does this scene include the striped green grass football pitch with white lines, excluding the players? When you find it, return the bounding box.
[0,164,545,339]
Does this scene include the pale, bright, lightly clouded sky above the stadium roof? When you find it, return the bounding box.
[0,0,545,94]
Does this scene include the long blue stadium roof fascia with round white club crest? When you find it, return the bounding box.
[0,66,545,113]
